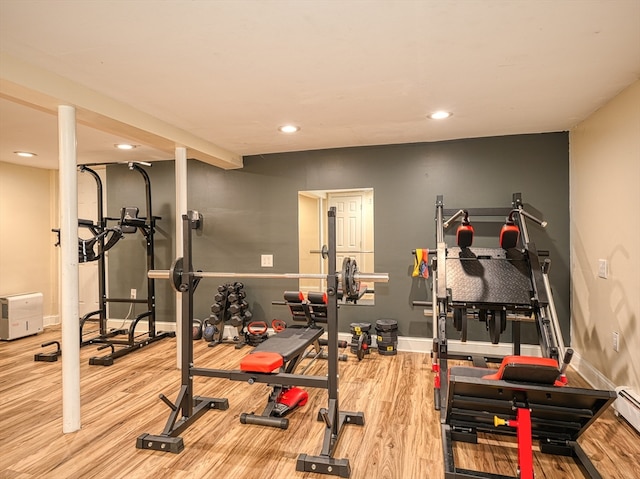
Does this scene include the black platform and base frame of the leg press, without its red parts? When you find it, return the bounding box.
[441,367,616,479]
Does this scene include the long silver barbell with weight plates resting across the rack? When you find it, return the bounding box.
[147,257,389,296]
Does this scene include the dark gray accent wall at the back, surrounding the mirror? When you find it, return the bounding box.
[107,132,570,343]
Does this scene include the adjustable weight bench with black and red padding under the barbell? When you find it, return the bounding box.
[240,291,327,429]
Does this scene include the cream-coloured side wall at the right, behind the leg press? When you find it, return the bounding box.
[569,81,640,392]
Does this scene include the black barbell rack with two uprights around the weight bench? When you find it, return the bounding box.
[136,207,364,477]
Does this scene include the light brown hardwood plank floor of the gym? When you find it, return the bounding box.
[0,328,640,479]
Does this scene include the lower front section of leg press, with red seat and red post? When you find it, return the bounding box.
[442,356,616,479]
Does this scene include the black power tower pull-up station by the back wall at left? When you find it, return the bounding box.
[78,162,176,366]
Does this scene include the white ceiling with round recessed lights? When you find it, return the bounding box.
[0,0,640,168]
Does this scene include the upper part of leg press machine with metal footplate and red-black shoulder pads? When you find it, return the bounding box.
[424,193,573,415]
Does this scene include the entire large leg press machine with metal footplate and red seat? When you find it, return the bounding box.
[422,193,616,479]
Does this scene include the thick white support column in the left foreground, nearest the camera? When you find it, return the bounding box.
[58,105,81,433]
